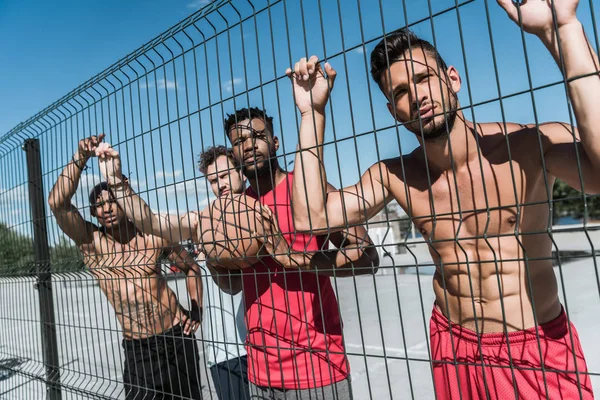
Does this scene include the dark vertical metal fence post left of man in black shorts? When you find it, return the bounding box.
[23,139,61,400]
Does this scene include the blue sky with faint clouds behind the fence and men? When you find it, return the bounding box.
[0,0,600,241]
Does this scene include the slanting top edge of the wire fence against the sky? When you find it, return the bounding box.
[0,0,231,150]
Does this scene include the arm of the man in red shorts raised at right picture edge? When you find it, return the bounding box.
[498,0,600,193]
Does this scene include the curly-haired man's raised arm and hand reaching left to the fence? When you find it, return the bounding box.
[96,143,198,243]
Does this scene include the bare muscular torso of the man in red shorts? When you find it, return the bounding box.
[388,126,561,333]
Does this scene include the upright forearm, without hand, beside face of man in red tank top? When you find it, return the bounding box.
[292,111,327,231]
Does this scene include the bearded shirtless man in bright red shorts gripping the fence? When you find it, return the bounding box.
[287,0,600,399]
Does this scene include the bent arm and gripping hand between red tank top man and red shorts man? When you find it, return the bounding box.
[286,56,390,234]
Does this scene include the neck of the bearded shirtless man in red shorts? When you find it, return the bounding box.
[421,115,478,171]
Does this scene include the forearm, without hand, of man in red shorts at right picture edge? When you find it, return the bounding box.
[541,21,600,168]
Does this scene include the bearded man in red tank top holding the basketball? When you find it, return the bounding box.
[225,108,379,400]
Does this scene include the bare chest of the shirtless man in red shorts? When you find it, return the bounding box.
[398,161,529,241]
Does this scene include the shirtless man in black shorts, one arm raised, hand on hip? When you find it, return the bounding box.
[48,135,202,400]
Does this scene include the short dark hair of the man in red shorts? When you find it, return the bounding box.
[371,28,448,90]
